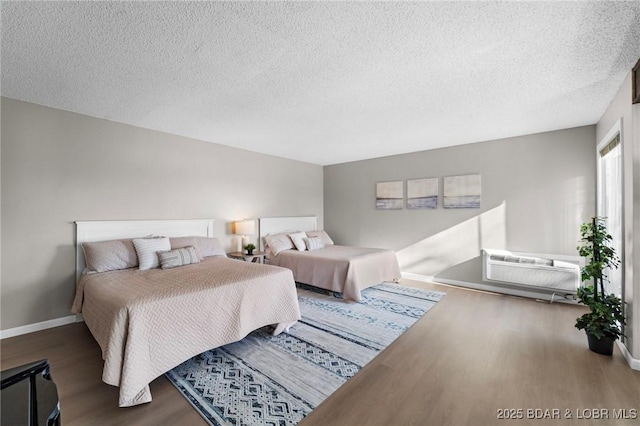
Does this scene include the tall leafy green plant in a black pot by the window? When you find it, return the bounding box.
[576,216,626,355]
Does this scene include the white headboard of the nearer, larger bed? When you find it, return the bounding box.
[76,219,213,280]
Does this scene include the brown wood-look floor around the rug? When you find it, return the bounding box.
[0,280,640,426]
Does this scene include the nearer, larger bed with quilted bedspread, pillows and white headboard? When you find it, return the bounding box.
[72,219,300,407]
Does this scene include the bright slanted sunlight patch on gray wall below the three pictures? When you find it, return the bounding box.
[396,201,507,275]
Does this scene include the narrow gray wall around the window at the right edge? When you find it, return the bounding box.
[596,73,640,359]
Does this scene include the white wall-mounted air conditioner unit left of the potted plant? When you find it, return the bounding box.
[482,249,580,294]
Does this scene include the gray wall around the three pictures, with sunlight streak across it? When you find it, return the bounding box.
[324,126,596,283]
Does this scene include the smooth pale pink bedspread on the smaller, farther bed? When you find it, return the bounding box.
[270,245,400,302]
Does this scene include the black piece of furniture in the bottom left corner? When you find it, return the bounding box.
[0,359,61,426]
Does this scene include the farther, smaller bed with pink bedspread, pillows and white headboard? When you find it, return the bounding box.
[259,216,400,302]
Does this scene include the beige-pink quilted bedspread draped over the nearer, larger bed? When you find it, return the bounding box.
[72,258,300,407]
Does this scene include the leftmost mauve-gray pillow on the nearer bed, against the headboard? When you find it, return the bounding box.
[82,239,138,272]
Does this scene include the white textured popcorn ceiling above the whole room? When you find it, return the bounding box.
[0,1,640,165]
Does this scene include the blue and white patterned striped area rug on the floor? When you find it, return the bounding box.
[166,283,444,426]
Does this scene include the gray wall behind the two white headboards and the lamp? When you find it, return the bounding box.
[1,98,323,330]
